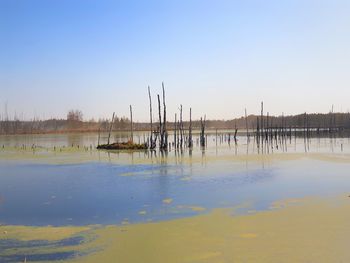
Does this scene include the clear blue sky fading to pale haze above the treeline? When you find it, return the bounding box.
[0,0,350,120]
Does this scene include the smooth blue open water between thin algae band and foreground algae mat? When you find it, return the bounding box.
[0,153,350,225]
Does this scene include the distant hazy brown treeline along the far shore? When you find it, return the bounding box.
[0,113,350,134]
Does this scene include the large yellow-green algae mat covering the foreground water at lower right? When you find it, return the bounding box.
[1,196,350,263]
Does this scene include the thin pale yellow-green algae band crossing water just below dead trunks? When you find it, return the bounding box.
[0,145,350,166]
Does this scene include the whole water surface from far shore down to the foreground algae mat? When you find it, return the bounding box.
[0,133,350,226]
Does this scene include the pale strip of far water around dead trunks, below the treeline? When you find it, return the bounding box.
[0,130,349,154]
